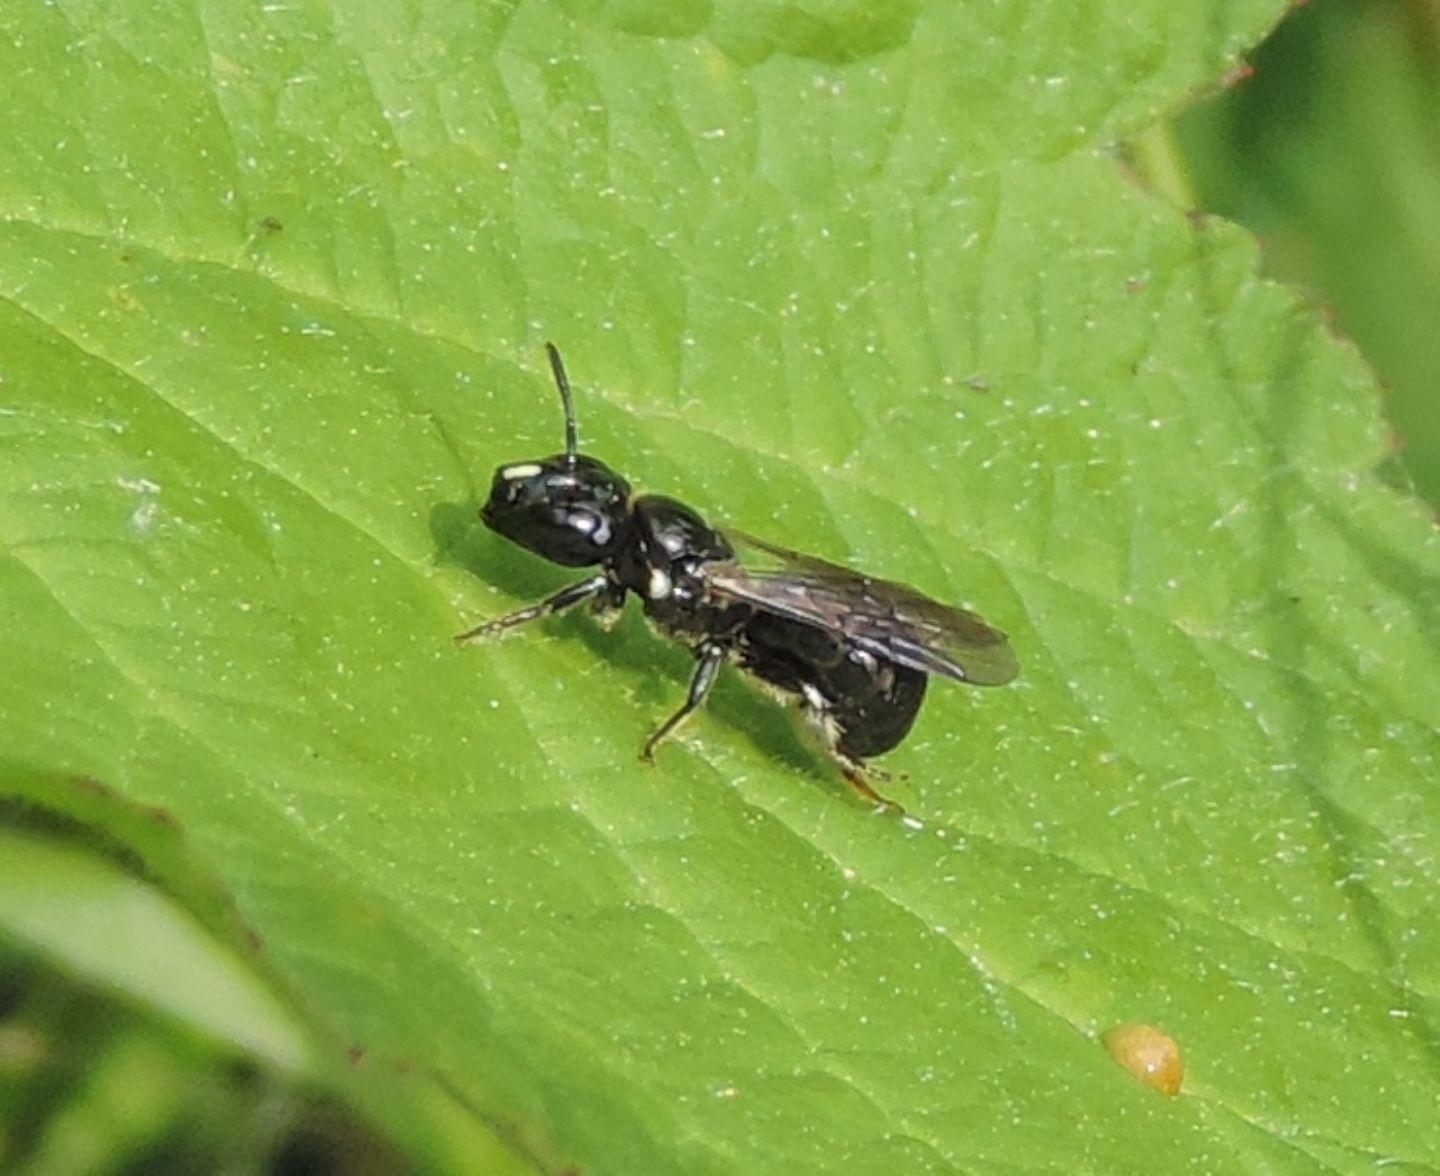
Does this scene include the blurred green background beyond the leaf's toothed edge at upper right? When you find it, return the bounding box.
[1176,0,1440,505]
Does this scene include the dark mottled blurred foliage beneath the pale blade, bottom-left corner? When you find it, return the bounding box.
[0,938,408,1176]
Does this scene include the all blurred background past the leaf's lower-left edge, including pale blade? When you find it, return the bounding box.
[0,823,533,1176]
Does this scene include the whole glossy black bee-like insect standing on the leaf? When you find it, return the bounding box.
[456,343,1018,808]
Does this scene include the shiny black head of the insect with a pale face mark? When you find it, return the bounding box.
[480,453,629,567]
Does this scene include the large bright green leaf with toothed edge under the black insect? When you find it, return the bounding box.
[0,0,1440,1173]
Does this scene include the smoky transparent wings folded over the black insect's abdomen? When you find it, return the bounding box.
[706,531,1020,687]
